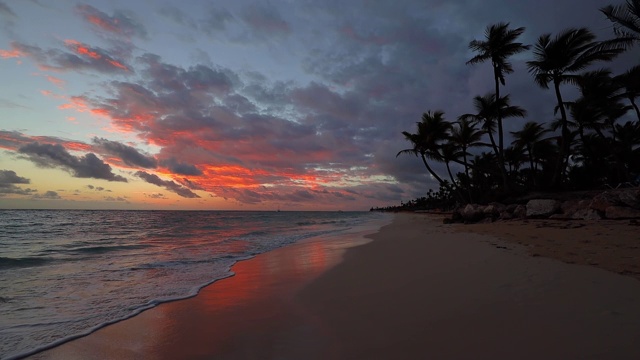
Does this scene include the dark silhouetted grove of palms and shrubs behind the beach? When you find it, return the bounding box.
[390,0,640,208]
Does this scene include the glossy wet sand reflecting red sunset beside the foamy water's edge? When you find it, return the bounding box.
[35,235,368,359]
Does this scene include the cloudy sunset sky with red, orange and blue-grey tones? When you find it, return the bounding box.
[0,0,639,211]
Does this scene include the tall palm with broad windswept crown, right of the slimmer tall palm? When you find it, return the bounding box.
[527,28,624,185]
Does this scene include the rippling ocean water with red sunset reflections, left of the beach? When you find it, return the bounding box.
[0,210,389,359]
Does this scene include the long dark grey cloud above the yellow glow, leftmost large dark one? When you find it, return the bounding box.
[18,143,127,182]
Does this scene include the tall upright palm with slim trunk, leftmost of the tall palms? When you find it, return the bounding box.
[467,23,530,168]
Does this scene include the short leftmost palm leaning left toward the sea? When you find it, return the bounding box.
[396,111,451,186]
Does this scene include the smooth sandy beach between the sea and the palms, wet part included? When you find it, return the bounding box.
[34,214,640,359]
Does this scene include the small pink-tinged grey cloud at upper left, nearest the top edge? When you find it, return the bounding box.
[76,4,147,39]
